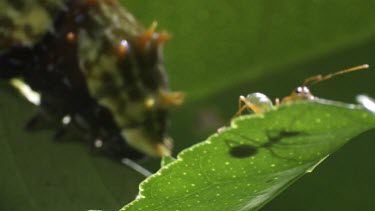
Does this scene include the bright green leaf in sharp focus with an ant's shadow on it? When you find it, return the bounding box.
[123,99,375,211]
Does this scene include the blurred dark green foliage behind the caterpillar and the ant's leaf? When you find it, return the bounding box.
[0,0,375,210]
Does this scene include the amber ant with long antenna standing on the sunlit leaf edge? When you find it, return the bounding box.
[232,64,369,119]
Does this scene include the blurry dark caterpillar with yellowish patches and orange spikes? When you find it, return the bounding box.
[0,0,183,158]
